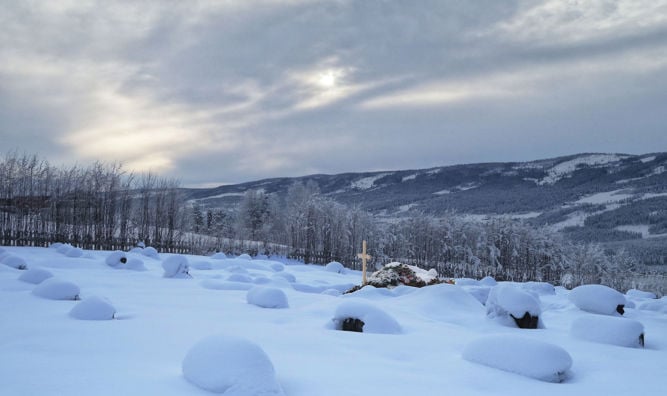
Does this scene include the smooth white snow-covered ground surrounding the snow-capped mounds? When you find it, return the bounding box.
[0,247,667,396]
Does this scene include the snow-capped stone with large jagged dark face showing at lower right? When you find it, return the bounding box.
[485,285,544,329]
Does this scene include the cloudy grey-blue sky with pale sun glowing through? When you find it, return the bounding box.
[0,0,667,187]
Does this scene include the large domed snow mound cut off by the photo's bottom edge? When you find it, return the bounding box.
[182,335,284,396]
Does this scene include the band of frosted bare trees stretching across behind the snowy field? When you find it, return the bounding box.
[0,153,665,294]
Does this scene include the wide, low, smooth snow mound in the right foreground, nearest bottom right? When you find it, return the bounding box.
[463,335,572,382]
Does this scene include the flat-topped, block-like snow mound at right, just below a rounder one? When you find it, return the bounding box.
[570,315,644,348]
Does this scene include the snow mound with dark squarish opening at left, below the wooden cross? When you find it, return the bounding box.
[332,301,402,334]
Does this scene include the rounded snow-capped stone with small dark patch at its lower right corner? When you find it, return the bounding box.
[569,285,626,315]
